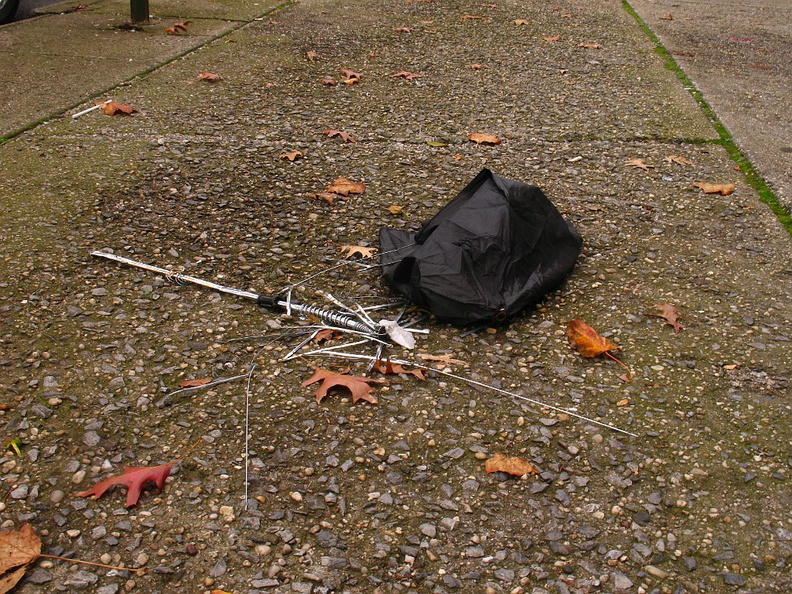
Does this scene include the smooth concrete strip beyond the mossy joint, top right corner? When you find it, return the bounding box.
[630,0,792,210]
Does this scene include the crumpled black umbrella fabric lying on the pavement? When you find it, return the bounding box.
[380,169,582,325]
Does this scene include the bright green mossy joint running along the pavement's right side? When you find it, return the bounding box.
[622,0,792,235]
